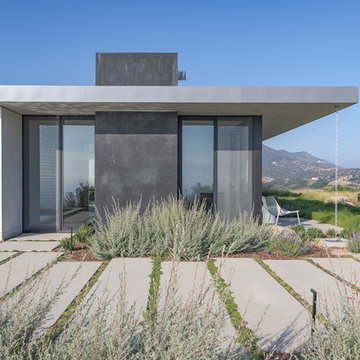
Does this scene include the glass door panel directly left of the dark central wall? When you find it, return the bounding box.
[63,119,95,229]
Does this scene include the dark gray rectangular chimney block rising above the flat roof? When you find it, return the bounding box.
[96,53,178,86]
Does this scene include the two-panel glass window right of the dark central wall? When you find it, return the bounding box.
[180,117,253,218]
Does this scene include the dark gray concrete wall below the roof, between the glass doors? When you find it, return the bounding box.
[95,112,178,213]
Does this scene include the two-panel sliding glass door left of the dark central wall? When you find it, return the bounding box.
[24,116,95,231]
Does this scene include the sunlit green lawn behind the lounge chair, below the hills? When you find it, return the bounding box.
[264,190,360,230]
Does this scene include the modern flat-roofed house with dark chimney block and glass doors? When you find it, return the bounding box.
[0,53,358,239]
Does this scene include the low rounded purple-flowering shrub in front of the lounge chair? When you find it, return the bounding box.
[271,231,311,257]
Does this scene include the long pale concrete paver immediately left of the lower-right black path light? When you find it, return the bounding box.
[216,258,310,352]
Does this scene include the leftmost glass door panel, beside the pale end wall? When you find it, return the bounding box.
[24,117,61,231]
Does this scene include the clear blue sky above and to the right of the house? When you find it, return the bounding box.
[0,0,360,167]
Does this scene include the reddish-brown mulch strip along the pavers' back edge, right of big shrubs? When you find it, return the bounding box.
[222,245,347,260]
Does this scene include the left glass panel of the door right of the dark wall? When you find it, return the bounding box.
[181,119,214,207]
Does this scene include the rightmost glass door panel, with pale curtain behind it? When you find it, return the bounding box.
[216,118,252,218]
